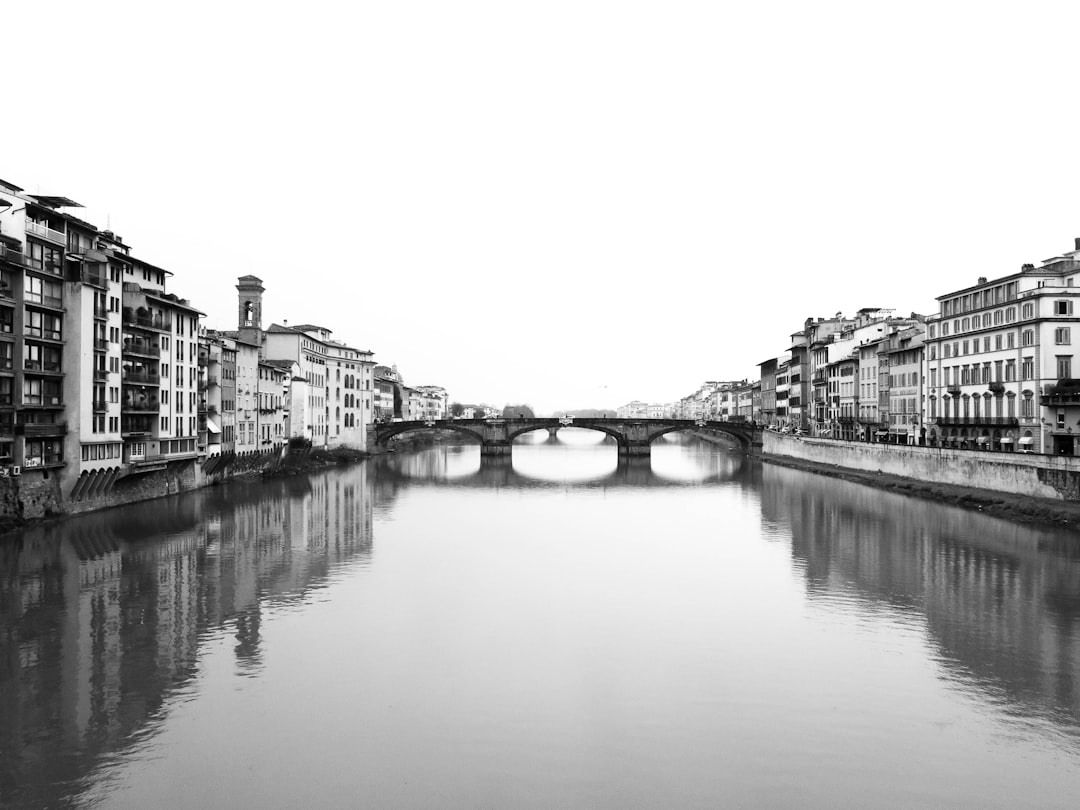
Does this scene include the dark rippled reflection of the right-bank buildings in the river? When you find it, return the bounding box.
[761,464,1080,730]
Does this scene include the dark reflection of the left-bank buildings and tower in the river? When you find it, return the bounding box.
[0,467,373,807]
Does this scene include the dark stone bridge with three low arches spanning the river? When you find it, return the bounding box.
[367,417,761,456]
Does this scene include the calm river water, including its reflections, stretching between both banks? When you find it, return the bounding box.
[0,430,1080,809]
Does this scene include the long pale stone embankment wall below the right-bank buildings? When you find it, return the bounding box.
[761,431,1080,501]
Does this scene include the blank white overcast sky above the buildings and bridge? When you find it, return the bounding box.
[0,0,1080,414]
